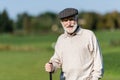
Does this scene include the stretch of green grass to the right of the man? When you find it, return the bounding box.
[96,30,120,80]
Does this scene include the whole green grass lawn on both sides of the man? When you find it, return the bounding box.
[0,31,120,80]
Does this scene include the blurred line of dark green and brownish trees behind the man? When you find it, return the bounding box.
[0,10,120,34]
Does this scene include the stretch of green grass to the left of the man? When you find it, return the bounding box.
[0,34,57,80]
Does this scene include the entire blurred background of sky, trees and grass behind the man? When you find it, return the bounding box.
[0,0,120,80]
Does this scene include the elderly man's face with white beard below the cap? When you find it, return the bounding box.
[61,16,77,33]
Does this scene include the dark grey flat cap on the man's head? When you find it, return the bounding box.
[58,8,78,19]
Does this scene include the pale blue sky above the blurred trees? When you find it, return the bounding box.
[0,0,120,19]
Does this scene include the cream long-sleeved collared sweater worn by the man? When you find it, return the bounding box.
[50,28,103,80]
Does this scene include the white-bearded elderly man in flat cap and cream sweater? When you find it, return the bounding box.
[45,8,103,80]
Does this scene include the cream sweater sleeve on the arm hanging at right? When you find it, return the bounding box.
[91,34,103,80]
